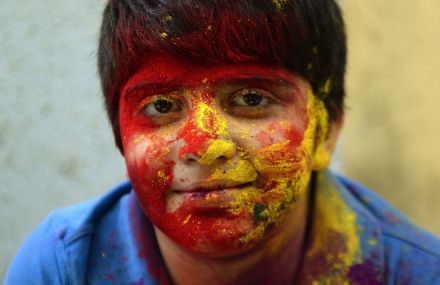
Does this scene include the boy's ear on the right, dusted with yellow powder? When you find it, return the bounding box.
[312,111,344,171]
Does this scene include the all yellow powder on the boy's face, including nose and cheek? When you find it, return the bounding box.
[188,91,329,248]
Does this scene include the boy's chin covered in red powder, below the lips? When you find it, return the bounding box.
[150,201,288,258]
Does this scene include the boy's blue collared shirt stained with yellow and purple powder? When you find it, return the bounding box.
[5,172,440,285]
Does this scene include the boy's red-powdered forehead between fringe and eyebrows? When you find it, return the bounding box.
[122,53,298,93]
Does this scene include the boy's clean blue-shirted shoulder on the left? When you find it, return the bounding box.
[5,182,131,284]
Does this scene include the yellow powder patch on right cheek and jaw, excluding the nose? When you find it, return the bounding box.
[235,92,329,243]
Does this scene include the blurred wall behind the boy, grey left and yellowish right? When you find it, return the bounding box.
[0,0,440,279]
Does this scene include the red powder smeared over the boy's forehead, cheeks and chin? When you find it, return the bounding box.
[120,54,310,252]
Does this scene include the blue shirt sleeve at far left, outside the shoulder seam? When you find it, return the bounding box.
[4,214,67,285]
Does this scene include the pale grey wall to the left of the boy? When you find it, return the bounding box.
[0,0,125,279]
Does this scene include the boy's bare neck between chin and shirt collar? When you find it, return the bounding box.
[155,191,308,285]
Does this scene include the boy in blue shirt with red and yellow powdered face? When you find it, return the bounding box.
[6,0,440,284]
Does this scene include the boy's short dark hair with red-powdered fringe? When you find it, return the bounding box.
[98,0,346,151]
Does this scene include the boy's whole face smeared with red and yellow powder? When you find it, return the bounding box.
[119,54,332,256]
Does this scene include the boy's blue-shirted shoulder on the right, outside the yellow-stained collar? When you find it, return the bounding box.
[337,176,440,284]
